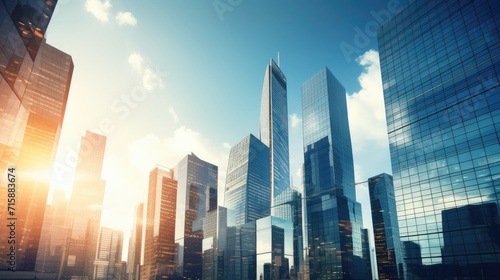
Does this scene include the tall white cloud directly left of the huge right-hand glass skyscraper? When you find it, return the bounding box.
[347,50,391,181]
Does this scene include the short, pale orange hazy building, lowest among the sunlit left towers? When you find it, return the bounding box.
[92,228,123,280]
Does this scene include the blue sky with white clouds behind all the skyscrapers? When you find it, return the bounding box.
[46,0,406,262]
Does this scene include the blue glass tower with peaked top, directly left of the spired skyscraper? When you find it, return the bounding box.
[219,134,271,279]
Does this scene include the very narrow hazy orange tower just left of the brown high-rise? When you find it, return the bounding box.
[127,203,143,280]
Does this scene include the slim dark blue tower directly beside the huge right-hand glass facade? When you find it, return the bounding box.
[368,173,403,280]
